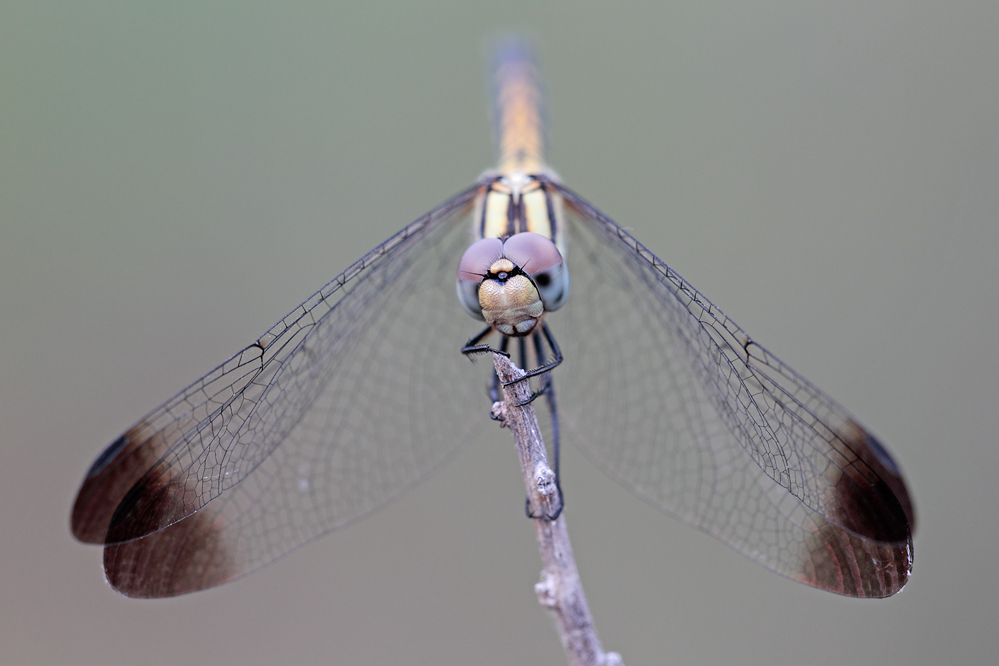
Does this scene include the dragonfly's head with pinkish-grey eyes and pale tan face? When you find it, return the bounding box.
[458,231,569,337]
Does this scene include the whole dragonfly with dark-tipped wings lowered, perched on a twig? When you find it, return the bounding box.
[71,41,915,597]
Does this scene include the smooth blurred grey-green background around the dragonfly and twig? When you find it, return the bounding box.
[0,0,999,666]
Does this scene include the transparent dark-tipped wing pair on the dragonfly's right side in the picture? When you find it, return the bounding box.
[551,183,914,597]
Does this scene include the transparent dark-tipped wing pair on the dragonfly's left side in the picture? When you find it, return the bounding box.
[72,188,489,596]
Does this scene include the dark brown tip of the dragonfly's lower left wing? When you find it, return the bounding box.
[104,511,240,598]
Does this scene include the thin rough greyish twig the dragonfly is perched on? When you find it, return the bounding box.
[493,354,622,666]
